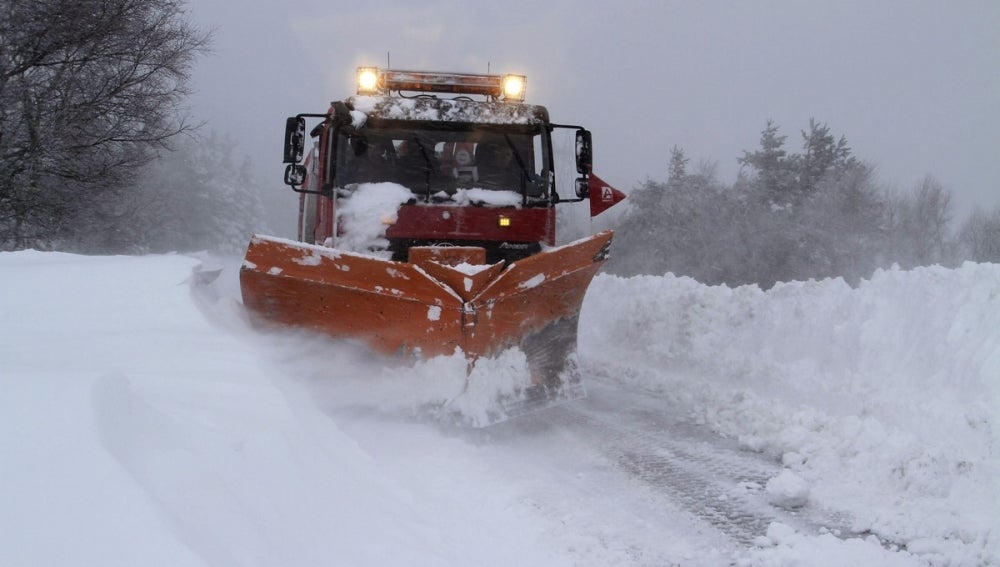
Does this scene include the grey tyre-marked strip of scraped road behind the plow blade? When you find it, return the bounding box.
[549,380,850,545]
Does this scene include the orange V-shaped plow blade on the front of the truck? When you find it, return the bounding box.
[240,231,612,418]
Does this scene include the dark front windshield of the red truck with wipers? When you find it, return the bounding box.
[335,123,552,205]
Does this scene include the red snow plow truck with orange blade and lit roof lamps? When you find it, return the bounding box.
[240,67,624,414]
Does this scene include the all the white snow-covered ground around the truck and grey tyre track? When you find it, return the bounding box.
[0,251,1000,567]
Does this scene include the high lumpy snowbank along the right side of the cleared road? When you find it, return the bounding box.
[580,264,1000,564]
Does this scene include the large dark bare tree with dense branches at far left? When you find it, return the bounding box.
[0,0,210,249]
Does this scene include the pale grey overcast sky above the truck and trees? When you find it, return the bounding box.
[189,0,1000,219]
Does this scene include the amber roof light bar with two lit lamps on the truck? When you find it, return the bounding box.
[357,67,527,102]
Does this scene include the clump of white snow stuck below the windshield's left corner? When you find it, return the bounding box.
[337,183,413,254]
